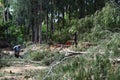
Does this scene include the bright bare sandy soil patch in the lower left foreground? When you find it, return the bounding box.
[0,64,47,80]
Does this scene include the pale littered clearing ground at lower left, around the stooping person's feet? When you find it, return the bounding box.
[0,46,48,80]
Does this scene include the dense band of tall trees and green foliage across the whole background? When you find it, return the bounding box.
[0,0,120,44]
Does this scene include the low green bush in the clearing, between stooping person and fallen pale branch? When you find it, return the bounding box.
[27,51,63,65]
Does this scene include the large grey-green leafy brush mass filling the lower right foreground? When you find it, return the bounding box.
[39,40,120,80]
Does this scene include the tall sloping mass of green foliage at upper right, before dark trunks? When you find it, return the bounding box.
[69,2,120,41]
